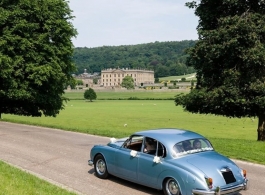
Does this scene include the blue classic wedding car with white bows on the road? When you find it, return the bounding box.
[88,129,248,195]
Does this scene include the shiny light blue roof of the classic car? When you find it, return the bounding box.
[134,128,205,145]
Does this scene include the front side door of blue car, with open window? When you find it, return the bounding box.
[115,135,143,182]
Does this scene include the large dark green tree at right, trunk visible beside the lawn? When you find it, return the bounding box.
[175,0,265,141]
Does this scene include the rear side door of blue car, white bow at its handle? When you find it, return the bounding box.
[138,139,166,187]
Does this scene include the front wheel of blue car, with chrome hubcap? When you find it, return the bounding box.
[94,154,109,179]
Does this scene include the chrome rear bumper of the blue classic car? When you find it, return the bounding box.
[192,179,249,195]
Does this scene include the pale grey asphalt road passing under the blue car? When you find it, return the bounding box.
[0,122,265,195]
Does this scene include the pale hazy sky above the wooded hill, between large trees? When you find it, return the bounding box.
[68,0,198,48]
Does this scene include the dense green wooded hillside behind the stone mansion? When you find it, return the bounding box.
[73,40,196,78]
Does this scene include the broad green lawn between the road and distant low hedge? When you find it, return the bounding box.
[3,100,265,164]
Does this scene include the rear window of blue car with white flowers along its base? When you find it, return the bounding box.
[172,139,214,158]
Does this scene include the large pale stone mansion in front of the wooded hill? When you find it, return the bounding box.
[100,68,155,87]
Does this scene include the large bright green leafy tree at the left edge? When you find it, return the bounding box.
[0,0,77,117]
